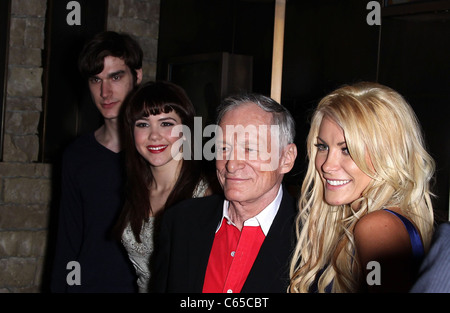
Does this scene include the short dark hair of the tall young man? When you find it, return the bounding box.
[78,31,144,83]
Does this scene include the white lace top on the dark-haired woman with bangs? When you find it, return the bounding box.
[122,180,208,293]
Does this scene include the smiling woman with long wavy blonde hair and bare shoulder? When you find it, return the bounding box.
[288,83,435,292]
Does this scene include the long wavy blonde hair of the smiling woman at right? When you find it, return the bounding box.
[288,82,435,292]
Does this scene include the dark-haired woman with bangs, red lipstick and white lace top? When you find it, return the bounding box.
[117,81,215,292]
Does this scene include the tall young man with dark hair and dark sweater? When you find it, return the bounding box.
[51,31,143,292]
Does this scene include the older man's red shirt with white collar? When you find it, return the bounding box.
[203,187,283,293]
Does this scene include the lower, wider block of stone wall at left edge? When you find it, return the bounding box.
[0,162,51,292]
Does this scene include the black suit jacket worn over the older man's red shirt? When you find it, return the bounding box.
[152,184,297,293]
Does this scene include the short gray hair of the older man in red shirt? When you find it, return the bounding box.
[216,93,295,149]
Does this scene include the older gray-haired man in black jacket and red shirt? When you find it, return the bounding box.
[153,94,297,293]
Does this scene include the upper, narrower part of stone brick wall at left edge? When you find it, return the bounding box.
[3,0,46,162]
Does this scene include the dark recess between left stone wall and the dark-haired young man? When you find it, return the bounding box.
[39,0,108,163]
